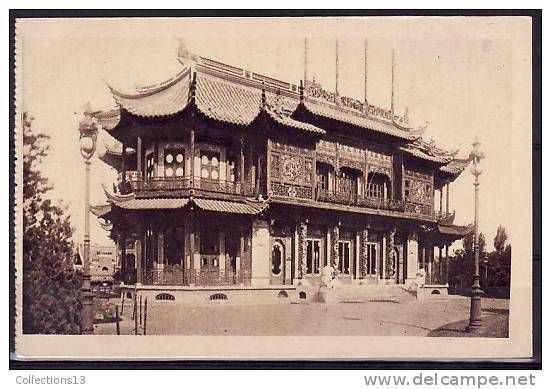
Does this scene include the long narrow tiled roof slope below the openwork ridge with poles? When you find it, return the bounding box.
[303,100,414,140]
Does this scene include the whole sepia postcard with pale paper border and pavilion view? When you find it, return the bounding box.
[14,16,534,359]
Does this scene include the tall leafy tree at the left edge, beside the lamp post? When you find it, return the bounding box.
[22,113,82,334]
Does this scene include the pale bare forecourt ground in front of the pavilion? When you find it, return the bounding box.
[95,296,509,337]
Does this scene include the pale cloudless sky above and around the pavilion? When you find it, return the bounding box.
[16,17,530,249]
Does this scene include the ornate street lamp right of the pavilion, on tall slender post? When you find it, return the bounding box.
[466,138,484,332]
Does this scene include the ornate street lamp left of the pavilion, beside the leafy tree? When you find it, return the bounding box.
[78,103,98,335]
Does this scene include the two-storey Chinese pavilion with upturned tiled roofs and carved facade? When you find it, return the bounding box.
[92,47,468,302]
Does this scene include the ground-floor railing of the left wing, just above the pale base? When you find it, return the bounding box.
[142,266,251,286]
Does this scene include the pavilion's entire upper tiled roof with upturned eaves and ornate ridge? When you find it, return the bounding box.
[96,56,460,168]
